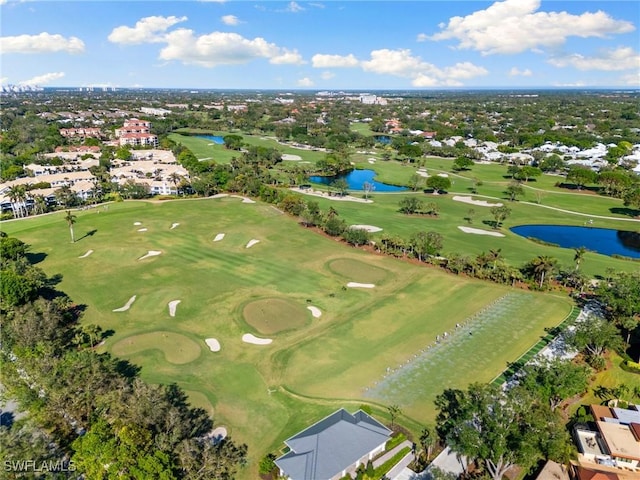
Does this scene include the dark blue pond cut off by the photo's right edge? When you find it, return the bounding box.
[511,225,640,258]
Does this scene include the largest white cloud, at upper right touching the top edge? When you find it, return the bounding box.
[418,0,635,55]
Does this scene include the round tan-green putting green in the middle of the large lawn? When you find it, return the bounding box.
[242,298,310,335]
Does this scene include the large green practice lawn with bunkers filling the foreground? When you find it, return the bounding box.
[2,197,586,478]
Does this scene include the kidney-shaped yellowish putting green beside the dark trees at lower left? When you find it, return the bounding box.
[111,331,201,365]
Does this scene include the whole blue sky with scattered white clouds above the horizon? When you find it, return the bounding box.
[0,0,640,91]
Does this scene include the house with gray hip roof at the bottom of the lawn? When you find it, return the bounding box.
[275,408,392,480]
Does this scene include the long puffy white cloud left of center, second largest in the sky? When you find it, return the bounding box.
[160,28,302,67]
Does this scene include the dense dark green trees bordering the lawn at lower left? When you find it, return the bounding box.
[0,234,247,480]
